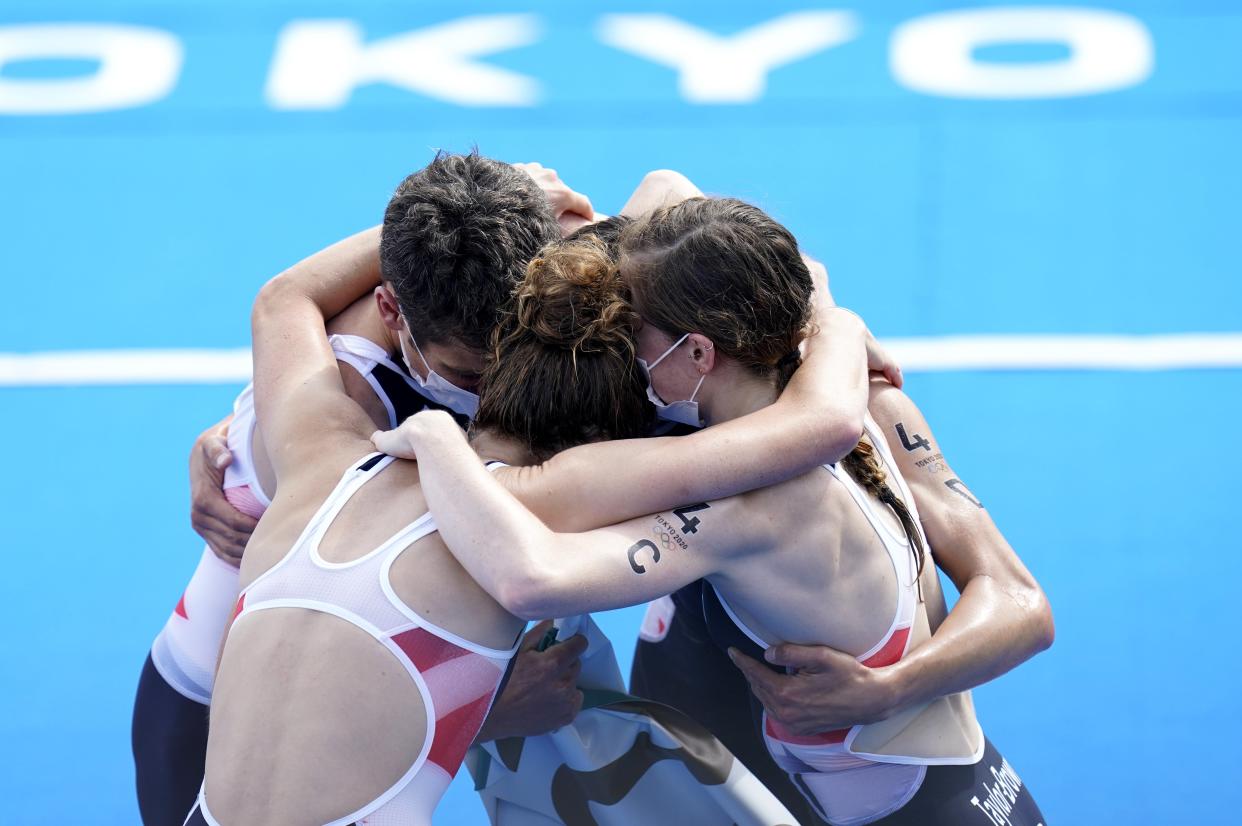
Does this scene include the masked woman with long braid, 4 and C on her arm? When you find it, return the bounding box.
[374,199,1042,826]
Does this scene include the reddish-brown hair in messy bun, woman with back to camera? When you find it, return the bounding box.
[474,234,652,462]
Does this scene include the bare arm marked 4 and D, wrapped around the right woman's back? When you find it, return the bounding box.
[734,383,1053,734]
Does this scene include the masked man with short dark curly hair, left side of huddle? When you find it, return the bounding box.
[133,153,592,826]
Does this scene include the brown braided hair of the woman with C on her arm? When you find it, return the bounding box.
[621,197,924,574]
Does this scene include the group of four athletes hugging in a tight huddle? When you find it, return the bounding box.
[133,153,1052,826]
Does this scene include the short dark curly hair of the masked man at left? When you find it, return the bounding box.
[380,150,560,350]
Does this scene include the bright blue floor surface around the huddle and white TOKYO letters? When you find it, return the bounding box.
[0,0,1242,826]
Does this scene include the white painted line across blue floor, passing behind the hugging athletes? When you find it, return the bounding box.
[0,333,1242,388]
